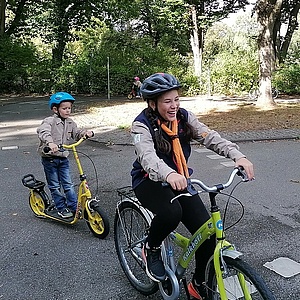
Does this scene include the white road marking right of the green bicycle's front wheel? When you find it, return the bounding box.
[263,257,300,278]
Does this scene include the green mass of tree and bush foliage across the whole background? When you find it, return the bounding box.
[0,0,300,96]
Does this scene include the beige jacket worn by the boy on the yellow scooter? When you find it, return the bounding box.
[37,114,85,157]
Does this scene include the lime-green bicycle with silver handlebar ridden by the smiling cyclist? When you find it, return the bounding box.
[114,168,275,300]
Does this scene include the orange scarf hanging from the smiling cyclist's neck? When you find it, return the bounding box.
[158,120,189,178]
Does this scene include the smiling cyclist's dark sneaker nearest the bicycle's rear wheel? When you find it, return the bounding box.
[142,245,166,282]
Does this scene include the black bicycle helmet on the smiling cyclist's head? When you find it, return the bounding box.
[141,73,181,100]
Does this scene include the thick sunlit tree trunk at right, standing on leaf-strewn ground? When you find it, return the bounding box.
[255,0,283,109]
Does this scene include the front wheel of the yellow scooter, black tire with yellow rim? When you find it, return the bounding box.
[84,203,110,239]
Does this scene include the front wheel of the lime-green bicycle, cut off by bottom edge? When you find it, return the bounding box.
[206,256,275,300]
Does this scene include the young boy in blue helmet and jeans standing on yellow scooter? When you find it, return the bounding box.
[37,92,94,218]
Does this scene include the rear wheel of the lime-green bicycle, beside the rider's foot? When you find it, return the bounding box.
[114,202,158,296]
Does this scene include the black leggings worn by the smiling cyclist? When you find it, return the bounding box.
[135,179,215,282]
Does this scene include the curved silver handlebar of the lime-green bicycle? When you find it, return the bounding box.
[171,167,249,203]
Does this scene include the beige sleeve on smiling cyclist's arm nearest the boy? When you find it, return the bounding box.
[131,121,175,181]
